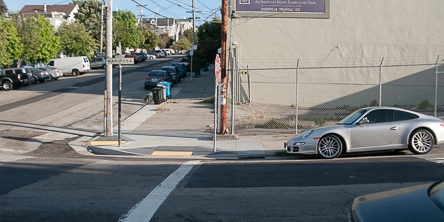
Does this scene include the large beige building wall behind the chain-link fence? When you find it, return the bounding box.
[231,0,444,107]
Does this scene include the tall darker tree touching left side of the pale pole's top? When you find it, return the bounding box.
[72,0,103,46]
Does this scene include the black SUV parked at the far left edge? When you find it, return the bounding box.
[0,68,32,91]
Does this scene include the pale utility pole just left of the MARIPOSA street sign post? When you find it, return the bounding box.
[104,0,113,137]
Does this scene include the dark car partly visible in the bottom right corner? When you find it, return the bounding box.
[350,181,444,222]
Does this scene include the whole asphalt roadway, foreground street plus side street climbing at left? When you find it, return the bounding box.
[0,57,444,222]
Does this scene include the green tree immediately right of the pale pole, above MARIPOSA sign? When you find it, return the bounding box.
[113,10,138,48]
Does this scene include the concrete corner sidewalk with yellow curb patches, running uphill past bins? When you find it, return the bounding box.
[69,66,284,159]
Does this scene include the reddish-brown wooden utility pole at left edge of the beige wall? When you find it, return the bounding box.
[219,0,228,134]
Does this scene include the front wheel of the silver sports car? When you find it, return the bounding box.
[317,135,342,159]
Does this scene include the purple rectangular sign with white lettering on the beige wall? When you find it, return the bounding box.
[230,0,330,19]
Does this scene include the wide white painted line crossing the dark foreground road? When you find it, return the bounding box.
[119,160,200,222]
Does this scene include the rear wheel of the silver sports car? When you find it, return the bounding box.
[409,129,434,154]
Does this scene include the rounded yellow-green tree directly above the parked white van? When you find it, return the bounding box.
[56,21,97,58]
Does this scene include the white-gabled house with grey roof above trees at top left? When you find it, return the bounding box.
[19,4,79,29]
